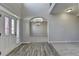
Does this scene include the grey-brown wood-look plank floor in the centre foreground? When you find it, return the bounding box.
[8,42,58,56]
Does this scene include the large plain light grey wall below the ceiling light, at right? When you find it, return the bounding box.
[49,15,79,42]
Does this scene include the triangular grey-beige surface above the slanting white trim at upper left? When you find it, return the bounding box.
[0,3,22,17]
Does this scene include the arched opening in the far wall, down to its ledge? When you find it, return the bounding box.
[30,17,48,37]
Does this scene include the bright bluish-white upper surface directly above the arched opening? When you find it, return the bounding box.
[22,3,50,18]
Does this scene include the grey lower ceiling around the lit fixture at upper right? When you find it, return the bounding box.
[51,3,79,15]
